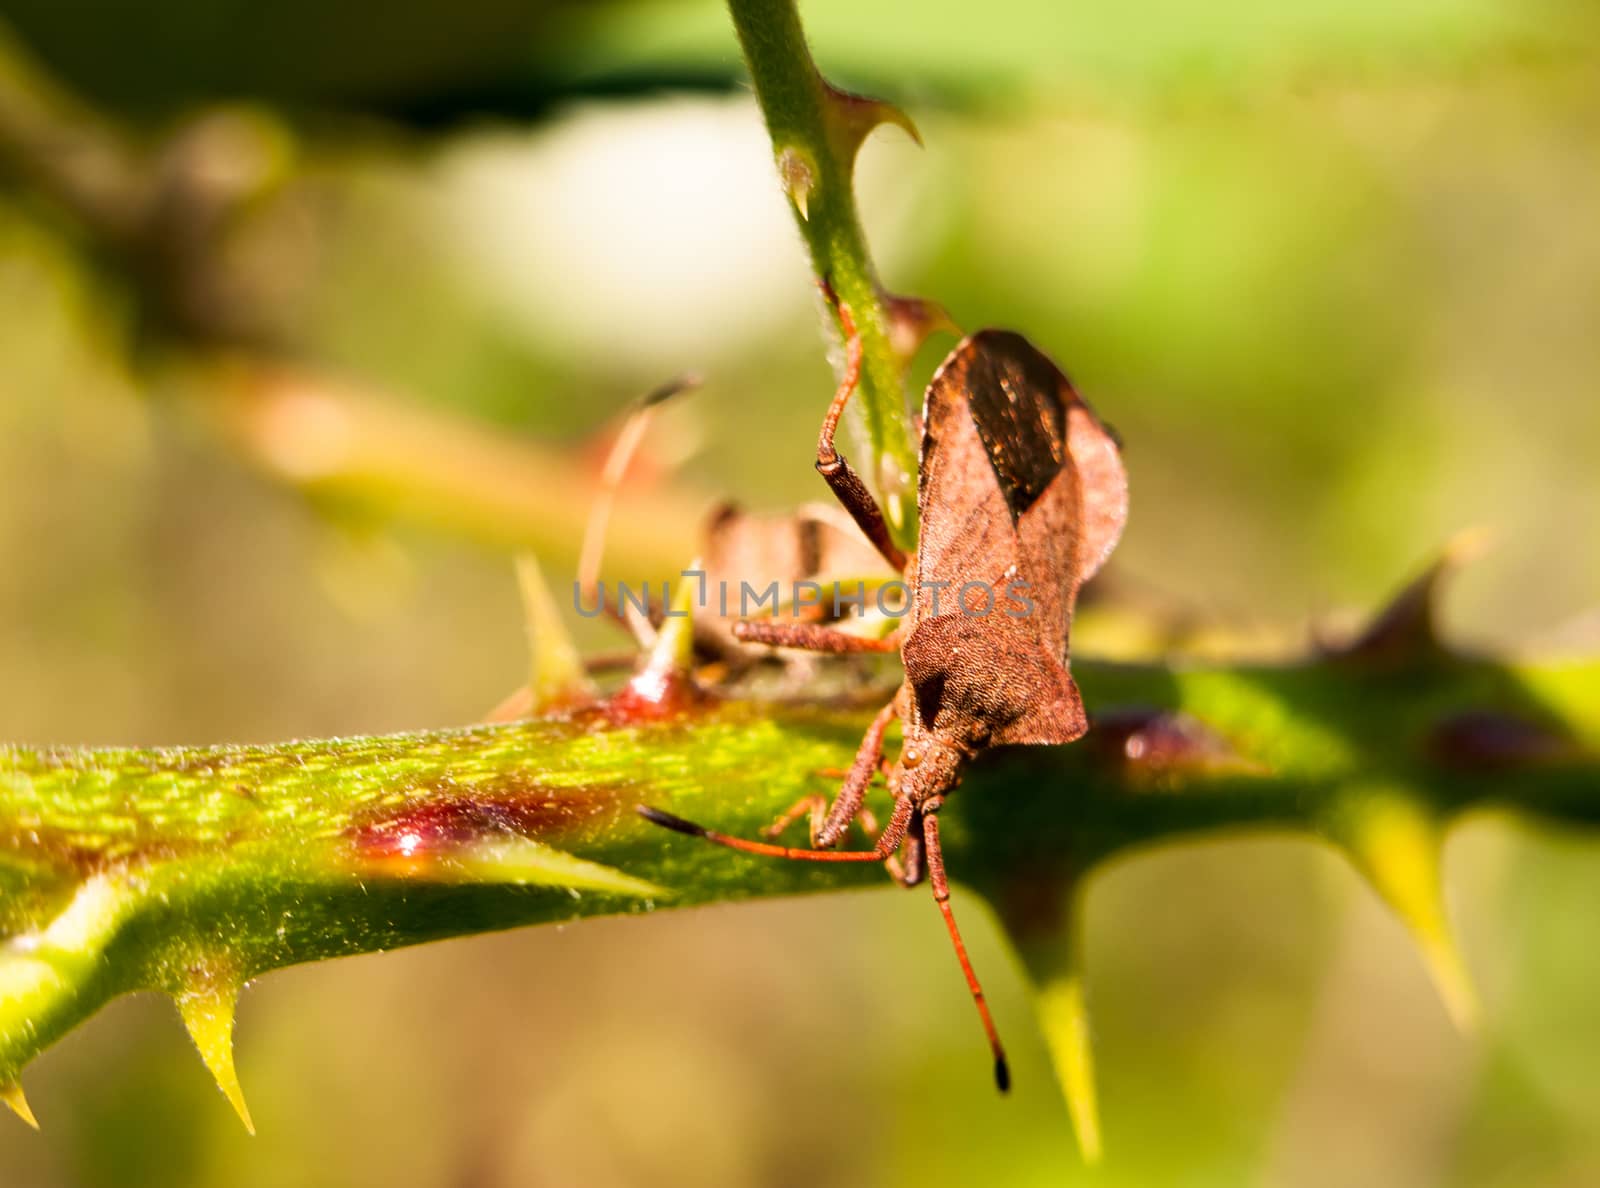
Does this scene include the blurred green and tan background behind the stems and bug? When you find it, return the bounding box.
[0,0,1600,1188]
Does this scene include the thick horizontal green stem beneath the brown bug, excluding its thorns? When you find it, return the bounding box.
[0,656,1600,1089]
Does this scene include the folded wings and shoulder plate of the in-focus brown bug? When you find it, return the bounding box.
[904,330,1128,743]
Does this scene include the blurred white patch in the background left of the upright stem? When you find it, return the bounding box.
[443,96,808,370]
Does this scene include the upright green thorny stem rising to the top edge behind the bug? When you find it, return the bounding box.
[728,0,917,549]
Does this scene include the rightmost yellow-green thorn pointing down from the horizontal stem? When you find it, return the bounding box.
[1339,794,1480,1033]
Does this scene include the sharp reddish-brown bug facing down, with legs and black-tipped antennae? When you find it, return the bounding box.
[640,307,1128,1090]
